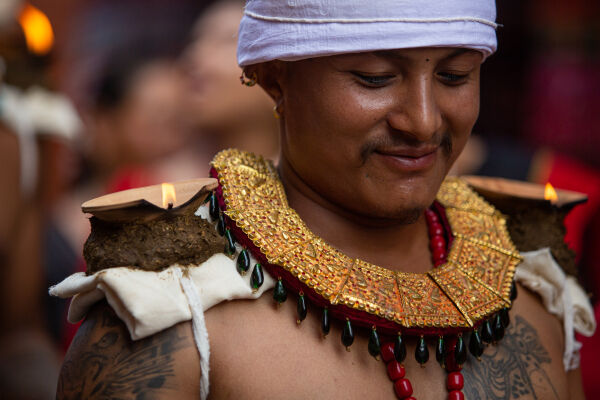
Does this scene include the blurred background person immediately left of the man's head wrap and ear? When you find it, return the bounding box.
[182,0,278,165]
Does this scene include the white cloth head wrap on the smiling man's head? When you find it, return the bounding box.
[238,0,497,66]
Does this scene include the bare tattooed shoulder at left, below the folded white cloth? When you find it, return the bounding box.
[57,302,200,399]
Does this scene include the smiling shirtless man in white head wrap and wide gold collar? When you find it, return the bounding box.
[53,0,583,399]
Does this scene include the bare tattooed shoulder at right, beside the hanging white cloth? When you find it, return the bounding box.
[463,287,581,399]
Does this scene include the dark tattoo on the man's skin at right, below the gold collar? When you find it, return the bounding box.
[462,315,558,400]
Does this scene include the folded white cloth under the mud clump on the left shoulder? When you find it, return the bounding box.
[50,253,275,340]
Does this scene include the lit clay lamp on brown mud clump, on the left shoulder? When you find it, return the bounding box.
[81,178,226,274]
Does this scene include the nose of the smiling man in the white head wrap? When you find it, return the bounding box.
[387,75,443,142]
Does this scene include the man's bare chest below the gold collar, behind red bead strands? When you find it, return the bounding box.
[209,294,567,400]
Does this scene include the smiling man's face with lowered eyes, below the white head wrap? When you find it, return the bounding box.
[279,48,482,223]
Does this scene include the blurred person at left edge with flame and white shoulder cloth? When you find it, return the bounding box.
[0,1,81,399]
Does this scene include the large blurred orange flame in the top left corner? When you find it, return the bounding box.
[19,3,54,55]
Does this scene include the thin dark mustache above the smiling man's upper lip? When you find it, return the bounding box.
[360,132,453,164]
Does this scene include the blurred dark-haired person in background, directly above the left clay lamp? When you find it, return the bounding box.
[85,47,199,191]
